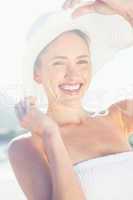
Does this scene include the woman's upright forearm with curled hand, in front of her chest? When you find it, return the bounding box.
[10,98,85,200]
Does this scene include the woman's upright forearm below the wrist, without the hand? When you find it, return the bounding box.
[42,134,85,200]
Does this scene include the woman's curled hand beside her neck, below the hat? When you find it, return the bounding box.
[15,97,59,138]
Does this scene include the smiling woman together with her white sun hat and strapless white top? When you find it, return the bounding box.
[9,2,133,200]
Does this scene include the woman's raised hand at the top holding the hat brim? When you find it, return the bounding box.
[63,0,133,24]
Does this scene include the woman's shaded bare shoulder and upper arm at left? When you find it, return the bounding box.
[8,134,52,200]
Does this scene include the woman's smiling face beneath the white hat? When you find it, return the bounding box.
[34,32,91,104]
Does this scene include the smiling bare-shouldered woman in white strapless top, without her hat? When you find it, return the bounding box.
[9,0,133,200]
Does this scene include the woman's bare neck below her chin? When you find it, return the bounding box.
[47,104,88,125]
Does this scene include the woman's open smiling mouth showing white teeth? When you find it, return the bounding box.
[59,83,83,95]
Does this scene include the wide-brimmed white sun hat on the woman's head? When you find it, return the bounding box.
[23,5,133,111]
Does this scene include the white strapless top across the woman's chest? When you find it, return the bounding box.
[73,151,133,200]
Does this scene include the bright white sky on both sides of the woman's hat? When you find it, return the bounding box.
[0,0,133,103]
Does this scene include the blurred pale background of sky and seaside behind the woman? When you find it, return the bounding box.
[0,0,133,200]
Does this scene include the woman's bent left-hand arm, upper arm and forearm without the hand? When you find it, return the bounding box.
[8,133,85,200]
